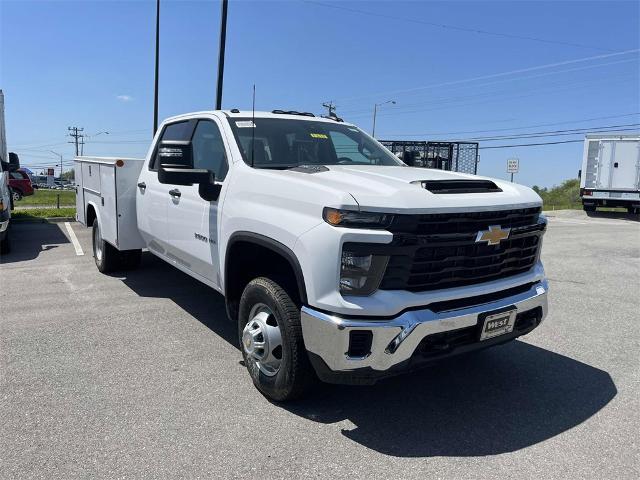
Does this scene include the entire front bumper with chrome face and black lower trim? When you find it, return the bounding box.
[301,279,548,384]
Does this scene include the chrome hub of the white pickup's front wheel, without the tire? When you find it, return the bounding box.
[242,303,282,377]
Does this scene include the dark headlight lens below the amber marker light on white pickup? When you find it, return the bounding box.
[340,249,389,295]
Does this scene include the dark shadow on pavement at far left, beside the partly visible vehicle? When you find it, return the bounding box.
[0,222,69,264]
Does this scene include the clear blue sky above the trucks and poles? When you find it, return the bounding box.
[0,0,640,186]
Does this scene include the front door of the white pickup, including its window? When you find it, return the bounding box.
[168,119,228,286]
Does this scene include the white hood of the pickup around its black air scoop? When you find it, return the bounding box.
[281,165,542,213]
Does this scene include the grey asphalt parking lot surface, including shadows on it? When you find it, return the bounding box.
[0,211,640,479]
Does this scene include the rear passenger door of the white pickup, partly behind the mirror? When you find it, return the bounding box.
[136,120,195,256]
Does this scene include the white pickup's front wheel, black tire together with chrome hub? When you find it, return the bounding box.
[238,277,315,402]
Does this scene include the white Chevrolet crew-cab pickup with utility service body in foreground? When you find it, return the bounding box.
[75,110,547,400]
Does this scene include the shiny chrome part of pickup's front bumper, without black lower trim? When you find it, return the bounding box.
[301,280,548,373]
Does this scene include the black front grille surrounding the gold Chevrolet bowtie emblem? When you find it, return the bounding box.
[380,208,545,291]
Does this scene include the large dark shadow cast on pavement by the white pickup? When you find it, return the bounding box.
[119,254,617,457]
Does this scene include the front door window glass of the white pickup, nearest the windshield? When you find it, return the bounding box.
[191,120,229,182]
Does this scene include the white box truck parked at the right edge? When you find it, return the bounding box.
[580,133,640,213]
